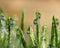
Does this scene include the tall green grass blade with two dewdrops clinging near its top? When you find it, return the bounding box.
[34,12,40,48]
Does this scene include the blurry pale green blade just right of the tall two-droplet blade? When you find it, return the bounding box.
[41,25,48,48]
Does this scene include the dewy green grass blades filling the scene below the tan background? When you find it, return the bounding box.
[0,9,60,48]
